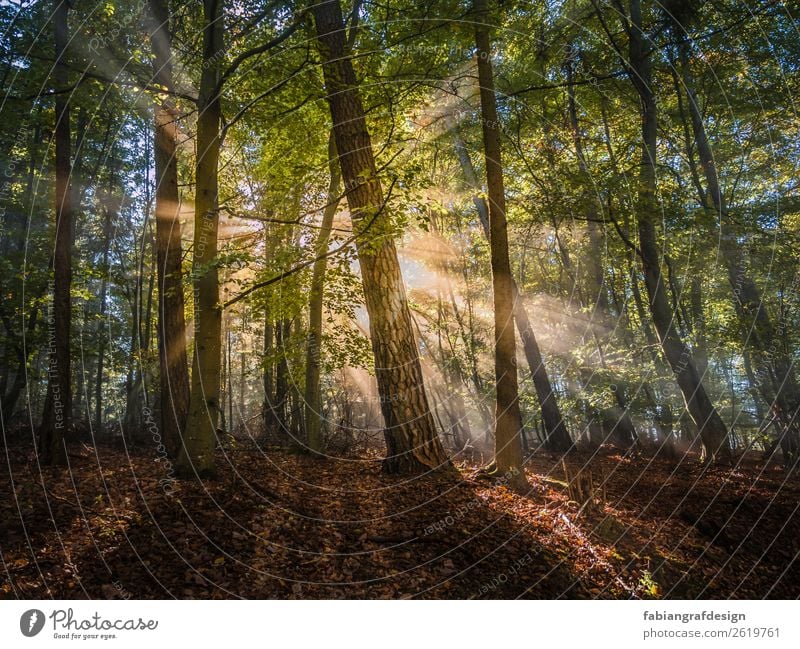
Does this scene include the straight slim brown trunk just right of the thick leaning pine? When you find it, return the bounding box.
[473,0,526,488]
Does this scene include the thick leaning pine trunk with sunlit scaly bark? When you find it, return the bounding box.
[313,0,449,473]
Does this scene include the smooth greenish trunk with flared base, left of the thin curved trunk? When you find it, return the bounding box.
[176,0,224,477]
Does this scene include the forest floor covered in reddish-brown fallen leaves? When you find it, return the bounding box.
[0,436,800,599]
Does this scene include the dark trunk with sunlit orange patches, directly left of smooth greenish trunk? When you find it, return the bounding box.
[150,0,189,457]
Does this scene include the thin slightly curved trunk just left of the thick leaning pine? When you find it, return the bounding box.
[305,132,342,453]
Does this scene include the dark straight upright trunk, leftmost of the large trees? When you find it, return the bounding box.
[38,0,72,464]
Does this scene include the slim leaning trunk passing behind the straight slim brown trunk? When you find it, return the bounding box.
[453,129,572,452]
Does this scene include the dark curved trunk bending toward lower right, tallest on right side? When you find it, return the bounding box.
[628,0,730,461]
